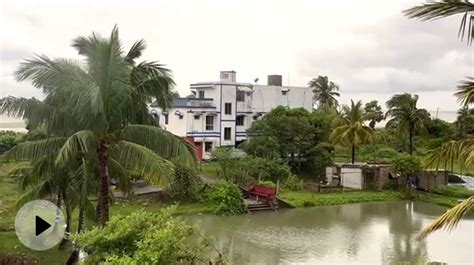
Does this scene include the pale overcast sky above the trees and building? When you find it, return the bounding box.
[0,0,474,111]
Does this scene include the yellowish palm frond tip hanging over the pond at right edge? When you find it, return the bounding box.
[417,196,474,240]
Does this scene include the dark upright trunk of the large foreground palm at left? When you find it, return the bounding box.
[97,140,109,225]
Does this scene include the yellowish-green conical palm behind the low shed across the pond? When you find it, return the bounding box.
[329,100,375,164]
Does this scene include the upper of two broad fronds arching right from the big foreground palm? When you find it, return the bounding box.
[121,125,196,166]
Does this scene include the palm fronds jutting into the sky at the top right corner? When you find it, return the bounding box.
[403,0,474,44]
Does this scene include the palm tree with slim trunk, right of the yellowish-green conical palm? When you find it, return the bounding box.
[386,93,429,156]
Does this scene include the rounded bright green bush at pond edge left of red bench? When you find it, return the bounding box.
[207,181,246,215]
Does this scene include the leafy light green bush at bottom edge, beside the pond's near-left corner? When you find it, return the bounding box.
[74,209,223,265]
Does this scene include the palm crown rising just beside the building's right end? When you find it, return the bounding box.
[308,75,340,108]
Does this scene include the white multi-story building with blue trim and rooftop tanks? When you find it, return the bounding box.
[151,71,313,159]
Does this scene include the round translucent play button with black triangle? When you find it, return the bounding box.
[15,200,66,250]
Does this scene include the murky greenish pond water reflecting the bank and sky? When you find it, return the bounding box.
[189,202,474,264]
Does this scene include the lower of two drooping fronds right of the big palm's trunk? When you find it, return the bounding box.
[111,140,174,186]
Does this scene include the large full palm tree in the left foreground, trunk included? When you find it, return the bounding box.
[0,27,195,224]
